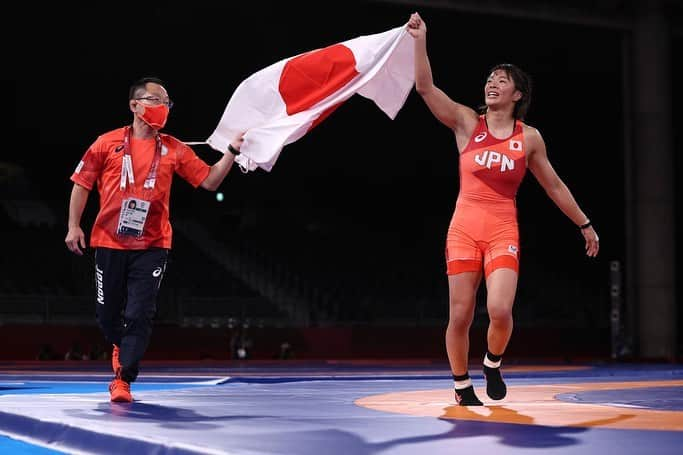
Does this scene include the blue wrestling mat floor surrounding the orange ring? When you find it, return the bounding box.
[0,362,683,455]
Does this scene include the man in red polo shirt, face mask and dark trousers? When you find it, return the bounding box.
[65,77,242,402]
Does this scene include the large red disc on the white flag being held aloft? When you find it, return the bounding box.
[278,44,358,116]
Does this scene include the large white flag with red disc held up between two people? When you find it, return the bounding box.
[206,25,415,171]
